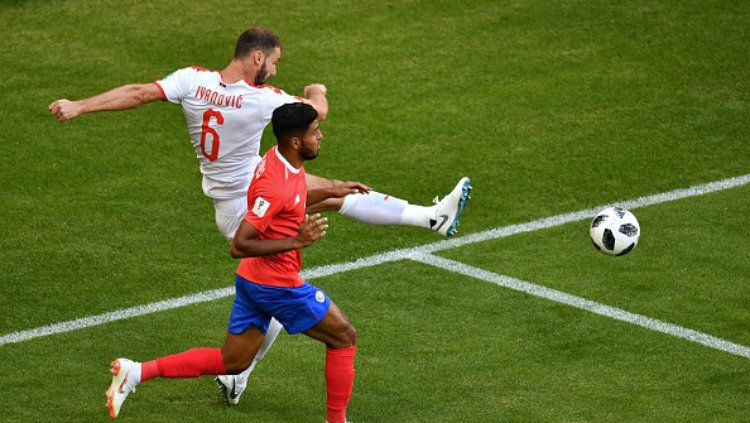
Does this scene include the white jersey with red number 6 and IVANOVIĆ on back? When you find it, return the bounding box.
[154,67,301,199]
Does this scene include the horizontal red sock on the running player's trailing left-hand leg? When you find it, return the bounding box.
[141,348,226,382]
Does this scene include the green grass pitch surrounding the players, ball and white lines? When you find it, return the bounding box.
[0,0,750,423]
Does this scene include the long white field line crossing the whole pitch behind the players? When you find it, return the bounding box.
[0,174,750,346]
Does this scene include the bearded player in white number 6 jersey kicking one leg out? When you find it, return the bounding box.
[49,28,471,410]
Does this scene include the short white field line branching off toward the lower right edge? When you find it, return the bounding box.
[411,253,750,358]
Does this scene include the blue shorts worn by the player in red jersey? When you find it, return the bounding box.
[229,275,331,335]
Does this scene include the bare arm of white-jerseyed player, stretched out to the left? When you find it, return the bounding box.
[48,84,162,122]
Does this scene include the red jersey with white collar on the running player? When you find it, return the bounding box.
[237,147,307,288]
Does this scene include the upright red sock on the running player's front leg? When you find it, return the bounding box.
[326,345,357,423]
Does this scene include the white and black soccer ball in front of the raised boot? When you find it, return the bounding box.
[589,207,641,256]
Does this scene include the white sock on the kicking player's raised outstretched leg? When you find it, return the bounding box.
[339,191,435,228]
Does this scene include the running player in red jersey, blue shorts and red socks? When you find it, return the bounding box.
[106,103,356,423]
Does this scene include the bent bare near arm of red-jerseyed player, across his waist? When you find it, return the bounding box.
[229,214,328,258]
